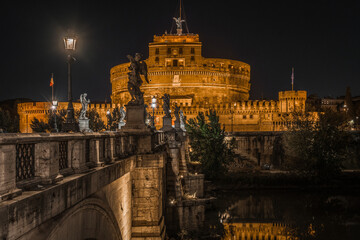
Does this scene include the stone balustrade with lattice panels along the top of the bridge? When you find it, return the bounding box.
[0,132,165,202]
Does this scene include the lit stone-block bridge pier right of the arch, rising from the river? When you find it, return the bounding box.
[132,154,166,240]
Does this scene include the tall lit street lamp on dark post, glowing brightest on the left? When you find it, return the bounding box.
[62,36,79,132]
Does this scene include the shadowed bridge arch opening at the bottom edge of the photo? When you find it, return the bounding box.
[47,198,122,240]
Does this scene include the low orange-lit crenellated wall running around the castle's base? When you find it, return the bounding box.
[18,91,306,133]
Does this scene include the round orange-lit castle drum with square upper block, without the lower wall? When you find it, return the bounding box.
[110,33,250,106]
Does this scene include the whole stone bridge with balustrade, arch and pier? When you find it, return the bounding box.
[0,131,184,239]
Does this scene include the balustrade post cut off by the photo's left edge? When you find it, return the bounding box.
[0,145,22,202]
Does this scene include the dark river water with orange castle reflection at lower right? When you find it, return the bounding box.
[167,189,360,240]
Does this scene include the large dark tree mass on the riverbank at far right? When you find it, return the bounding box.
[284,110,354,180]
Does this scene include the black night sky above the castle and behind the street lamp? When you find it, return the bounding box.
[0,0,360,101]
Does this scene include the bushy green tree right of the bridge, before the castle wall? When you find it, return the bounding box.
[186,110,235,178]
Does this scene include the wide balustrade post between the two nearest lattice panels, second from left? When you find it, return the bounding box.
[35,142,63,184]
